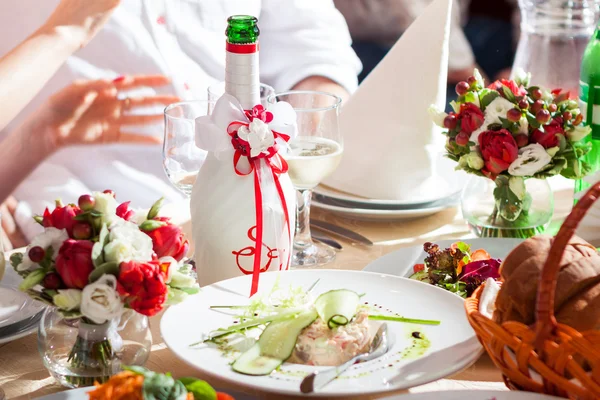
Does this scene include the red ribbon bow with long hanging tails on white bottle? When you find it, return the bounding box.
[227,105,292,296]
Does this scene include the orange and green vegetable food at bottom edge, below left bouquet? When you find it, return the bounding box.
[88,367,234,400]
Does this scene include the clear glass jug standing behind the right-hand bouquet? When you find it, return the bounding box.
[512,0,600,94]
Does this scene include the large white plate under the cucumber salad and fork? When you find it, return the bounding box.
[160,270,482,397]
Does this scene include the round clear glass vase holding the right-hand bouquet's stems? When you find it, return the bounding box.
[461,176,554,239]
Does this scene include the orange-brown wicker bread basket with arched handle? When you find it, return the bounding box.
[465,182,600,400]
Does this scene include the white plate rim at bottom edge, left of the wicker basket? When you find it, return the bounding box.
[385,390,559,400]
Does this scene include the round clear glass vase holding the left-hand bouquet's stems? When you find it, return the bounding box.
[38,307,152,388]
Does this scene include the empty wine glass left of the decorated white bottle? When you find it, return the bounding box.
[163,100,214,197]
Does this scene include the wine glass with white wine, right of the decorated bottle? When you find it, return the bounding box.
[268,90,344,267]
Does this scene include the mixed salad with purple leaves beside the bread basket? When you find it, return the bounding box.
[410,242,501,298]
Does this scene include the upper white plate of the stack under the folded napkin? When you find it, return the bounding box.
[311,199,454,221]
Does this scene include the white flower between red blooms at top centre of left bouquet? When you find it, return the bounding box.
[104,219,154,264]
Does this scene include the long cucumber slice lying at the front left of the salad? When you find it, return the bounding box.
[232,309,317,375]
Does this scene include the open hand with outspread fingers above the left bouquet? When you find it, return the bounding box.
[37,75,179,152]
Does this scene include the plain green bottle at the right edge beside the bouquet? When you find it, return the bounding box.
[575,25,600,201]
